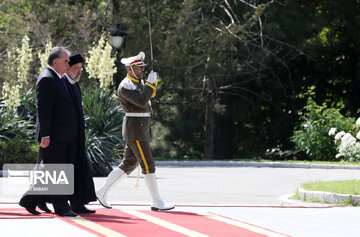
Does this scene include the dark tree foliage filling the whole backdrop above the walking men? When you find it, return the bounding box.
[0,0,360,159]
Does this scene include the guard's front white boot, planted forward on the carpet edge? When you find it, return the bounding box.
[144,173,175,211]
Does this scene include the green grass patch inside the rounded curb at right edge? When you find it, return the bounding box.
[302,179,360,195]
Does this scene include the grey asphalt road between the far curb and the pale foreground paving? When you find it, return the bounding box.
[91,167,360,205]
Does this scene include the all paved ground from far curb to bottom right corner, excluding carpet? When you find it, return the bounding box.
[0,167,360,237]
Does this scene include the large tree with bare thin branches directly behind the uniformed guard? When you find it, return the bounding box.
[107,1,301,159]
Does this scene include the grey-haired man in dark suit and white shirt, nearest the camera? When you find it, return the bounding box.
[19,46,79,216]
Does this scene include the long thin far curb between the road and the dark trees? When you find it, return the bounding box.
[155,161,360,170]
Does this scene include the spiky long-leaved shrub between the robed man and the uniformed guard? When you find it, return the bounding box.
[83,89,125,176]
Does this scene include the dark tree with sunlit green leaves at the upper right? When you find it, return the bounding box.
[265,0,360,157]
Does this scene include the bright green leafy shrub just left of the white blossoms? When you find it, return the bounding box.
[291,97,355,161]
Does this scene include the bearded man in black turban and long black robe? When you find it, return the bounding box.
[64,54,96,213]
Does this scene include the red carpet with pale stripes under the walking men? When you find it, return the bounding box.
[0,208,287,237]
